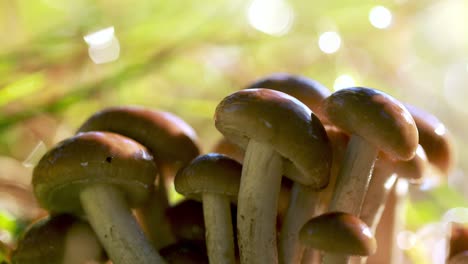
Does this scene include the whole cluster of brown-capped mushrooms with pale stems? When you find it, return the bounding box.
[5,73,456,264]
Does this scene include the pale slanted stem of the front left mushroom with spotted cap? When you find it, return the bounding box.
[80,184,165,264]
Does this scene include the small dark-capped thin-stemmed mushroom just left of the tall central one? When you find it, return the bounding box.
[174,153,242,264]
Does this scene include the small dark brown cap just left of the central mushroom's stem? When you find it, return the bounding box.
[174,153,242,202]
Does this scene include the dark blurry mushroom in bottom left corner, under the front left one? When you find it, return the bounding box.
[11,214,105,264]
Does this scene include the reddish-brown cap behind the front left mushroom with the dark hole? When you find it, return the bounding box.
[78,106,200,165]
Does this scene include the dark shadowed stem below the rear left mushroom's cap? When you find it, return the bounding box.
[137,164,176,249]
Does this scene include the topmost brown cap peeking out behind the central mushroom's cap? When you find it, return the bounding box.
[246,73,331,113]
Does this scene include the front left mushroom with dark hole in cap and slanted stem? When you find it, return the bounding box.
[32,132,163,264]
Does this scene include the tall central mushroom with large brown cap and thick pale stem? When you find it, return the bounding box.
[215,89,330,264]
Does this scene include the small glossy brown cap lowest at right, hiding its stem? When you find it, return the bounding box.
[299,212,377,256]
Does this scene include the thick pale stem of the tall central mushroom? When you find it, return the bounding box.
[237,140,283,264]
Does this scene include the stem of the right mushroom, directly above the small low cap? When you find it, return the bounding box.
[329,135,378,216]
